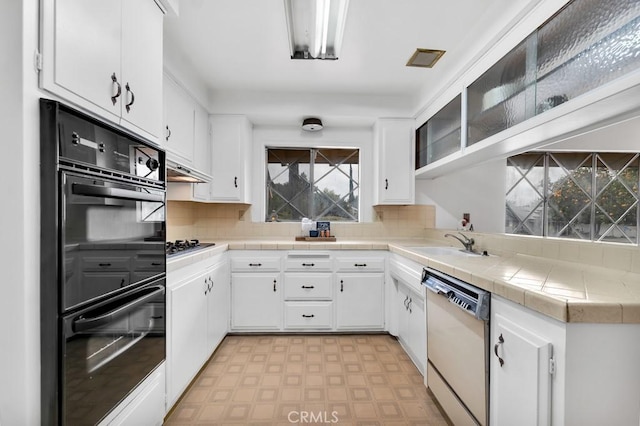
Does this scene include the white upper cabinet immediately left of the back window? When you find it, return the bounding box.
[211,115,252,204]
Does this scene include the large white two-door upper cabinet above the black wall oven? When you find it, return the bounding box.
[41,0,163,142]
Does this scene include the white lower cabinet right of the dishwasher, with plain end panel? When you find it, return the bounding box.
[489,294,640,426]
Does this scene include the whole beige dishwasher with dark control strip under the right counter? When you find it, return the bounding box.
[422,268,491,426]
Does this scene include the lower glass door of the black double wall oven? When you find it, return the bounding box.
[61,279,165,425]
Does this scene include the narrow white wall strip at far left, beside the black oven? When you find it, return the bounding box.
[0,0,40,425]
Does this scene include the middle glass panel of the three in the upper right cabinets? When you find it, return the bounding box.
[467,34,535,145]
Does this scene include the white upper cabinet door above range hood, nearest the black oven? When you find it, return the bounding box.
[162,74,196,163]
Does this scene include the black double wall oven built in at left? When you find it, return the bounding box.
[40,99,166,425]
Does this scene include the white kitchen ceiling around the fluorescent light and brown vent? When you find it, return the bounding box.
[164,0,536,125]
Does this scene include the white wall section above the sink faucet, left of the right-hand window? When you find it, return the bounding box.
[416,160,506,233]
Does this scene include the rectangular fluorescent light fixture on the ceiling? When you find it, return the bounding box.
[284,0,349,59]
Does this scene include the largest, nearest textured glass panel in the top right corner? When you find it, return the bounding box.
[536,0,640,113]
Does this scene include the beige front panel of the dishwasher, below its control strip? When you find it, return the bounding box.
[427,291,488,425]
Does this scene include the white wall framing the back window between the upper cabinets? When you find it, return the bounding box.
[251,126,373,222]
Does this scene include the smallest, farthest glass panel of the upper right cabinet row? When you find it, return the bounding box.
[416,95,462,169]
